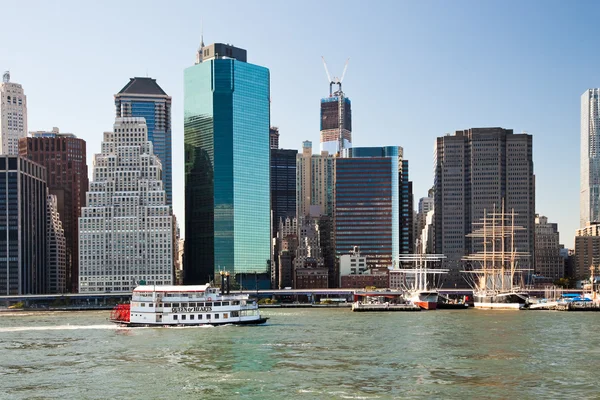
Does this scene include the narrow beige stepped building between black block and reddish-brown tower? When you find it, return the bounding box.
[46,194,67,293]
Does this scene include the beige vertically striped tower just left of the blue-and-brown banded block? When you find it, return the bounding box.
[296,140,335,217]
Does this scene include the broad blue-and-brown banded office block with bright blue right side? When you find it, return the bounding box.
[334,146,412,268]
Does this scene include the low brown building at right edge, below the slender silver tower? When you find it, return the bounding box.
[570,222,600,279]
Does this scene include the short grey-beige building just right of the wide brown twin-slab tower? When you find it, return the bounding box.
[535,215,565,281]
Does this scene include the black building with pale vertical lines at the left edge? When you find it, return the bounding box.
[0,155,48,295]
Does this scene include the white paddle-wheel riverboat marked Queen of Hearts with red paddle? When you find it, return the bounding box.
[110,276,268,327]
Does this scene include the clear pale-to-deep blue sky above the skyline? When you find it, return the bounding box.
[0,0,600,247]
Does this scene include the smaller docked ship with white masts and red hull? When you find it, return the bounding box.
[393,254,448,310]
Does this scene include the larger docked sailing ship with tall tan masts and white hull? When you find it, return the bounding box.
[463,204,530,310]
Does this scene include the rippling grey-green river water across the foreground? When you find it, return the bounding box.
[0,309,600,400]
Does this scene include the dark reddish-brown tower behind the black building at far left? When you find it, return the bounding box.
[19,128,89,293]
